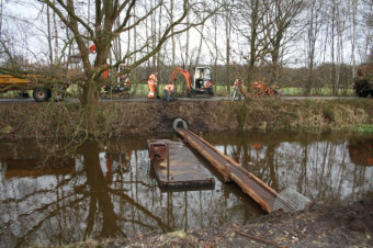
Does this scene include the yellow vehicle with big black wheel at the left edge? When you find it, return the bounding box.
[0,74,68,102]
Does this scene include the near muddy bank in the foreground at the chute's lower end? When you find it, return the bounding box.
[58,196,373,248]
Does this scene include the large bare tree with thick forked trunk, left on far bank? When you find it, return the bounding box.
[1,0,215,137]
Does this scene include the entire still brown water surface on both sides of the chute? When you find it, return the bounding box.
[0,133,373,247]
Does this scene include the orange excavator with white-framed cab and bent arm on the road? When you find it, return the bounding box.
[170,66,214,97]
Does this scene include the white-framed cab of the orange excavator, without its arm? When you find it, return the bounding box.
[191,66,214,95]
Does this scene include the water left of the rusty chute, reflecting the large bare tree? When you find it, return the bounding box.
[0,141,256,247]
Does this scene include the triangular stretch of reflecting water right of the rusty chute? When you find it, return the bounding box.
[207,134,373,204]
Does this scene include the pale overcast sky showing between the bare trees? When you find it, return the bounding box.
[2,0,373,67]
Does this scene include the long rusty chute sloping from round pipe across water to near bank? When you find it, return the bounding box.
[176,128,295,213]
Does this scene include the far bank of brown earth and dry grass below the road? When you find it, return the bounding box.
[0,98,373,138]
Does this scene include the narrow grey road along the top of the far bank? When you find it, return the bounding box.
[0,96,356,104]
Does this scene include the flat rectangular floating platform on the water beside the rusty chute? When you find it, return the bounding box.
[148,139,215,189]
